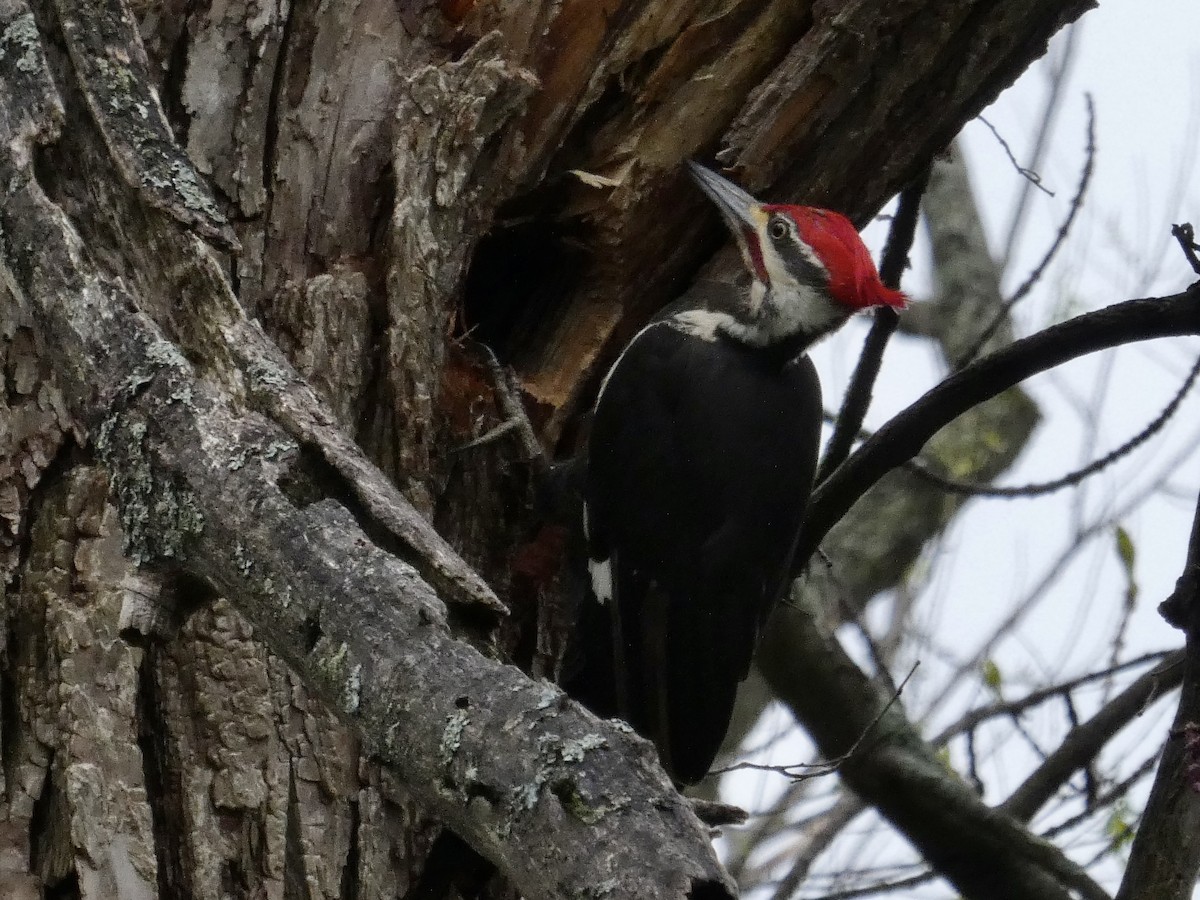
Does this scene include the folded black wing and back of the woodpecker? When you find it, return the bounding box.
[583,323,821,782]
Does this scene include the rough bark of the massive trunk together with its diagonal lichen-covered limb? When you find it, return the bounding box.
[0,0,1104,900]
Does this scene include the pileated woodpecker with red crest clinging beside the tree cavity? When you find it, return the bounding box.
[568,163,905,784]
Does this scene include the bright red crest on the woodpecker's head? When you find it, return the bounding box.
[764,204,908,310]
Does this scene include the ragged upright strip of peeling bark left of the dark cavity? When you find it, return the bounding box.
[386,32,536,512]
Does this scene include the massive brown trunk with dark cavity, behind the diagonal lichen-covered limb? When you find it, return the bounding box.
[0,0,1090,900]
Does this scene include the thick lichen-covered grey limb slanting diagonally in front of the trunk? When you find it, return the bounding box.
[0,2,733,900]
